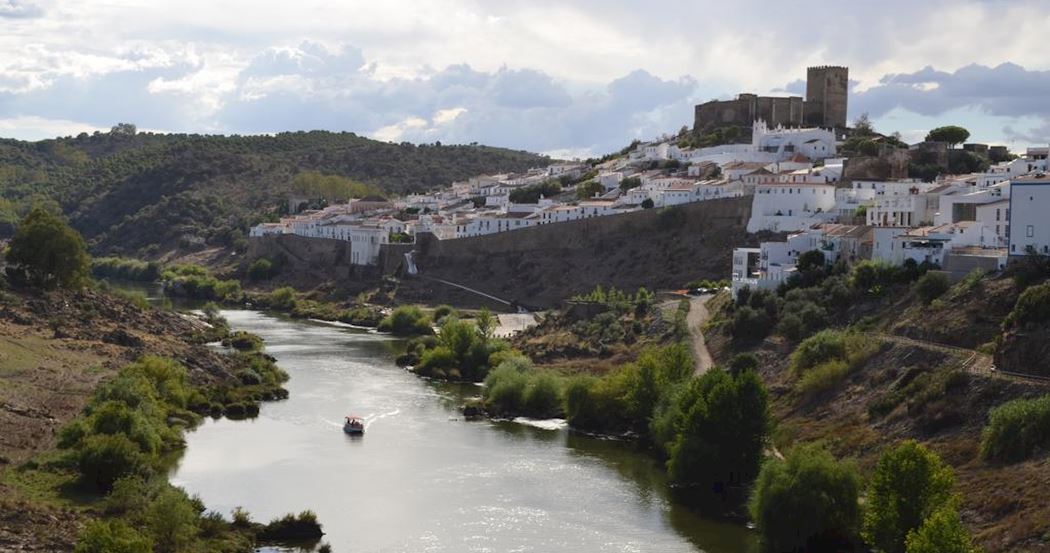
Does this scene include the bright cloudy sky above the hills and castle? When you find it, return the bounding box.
[0,0,1050,157]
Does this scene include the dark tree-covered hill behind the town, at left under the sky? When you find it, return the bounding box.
[0,130,549,258]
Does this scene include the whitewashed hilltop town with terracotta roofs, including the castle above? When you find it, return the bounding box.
[250,66,1050,298]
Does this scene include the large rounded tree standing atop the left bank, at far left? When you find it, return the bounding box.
[7,207,91,290]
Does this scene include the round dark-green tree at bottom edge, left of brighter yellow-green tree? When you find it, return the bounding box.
[748,445,860,552]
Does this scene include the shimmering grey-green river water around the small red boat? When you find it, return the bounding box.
[171,311,754,553]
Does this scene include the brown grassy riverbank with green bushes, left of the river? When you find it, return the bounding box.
[0,289,323,551]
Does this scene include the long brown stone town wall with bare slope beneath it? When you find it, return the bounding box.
[416,196,755,307]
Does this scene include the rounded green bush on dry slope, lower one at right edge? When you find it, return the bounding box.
[981,396,1050,463]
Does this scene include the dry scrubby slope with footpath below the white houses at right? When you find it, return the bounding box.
[705,266,1050,551]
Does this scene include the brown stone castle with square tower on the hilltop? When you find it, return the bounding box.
[693,65,849,132]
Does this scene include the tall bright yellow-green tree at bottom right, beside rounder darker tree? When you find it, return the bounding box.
[863,440,954,553]
